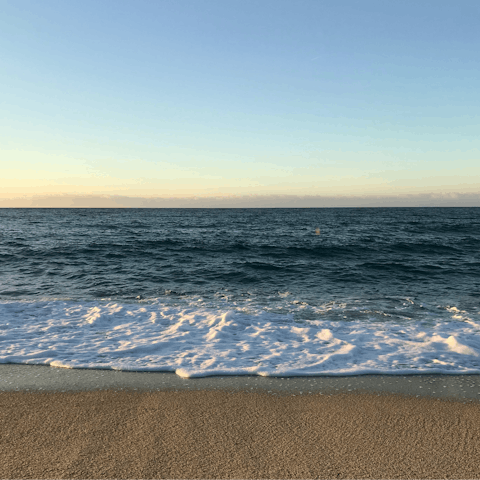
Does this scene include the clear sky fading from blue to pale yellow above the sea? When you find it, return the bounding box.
[0,0,480,206]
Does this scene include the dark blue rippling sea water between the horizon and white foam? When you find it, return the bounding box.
[0,208,480,376]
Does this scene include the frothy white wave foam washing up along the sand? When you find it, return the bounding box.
[0,298,480,377]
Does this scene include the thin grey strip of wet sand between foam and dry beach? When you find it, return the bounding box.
[0,364,480,402]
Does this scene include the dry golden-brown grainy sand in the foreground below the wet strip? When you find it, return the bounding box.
[0,390,480,480]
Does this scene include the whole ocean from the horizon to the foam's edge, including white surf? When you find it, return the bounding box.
[0,208,480,377]
